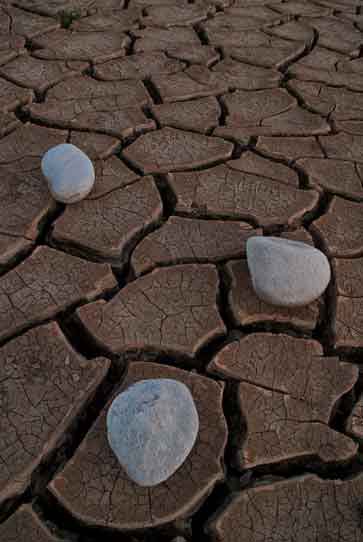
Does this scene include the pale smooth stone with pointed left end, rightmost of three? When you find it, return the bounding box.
[247,237,330,307]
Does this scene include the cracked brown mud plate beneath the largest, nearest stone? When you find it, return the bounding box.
[50,362,227,531]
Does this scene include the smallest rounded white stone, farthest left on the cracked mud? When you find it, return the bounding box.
[41,143,95,203]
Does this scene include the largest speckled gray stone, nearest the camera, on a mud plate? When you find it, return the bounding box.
[107,378,199,486]
